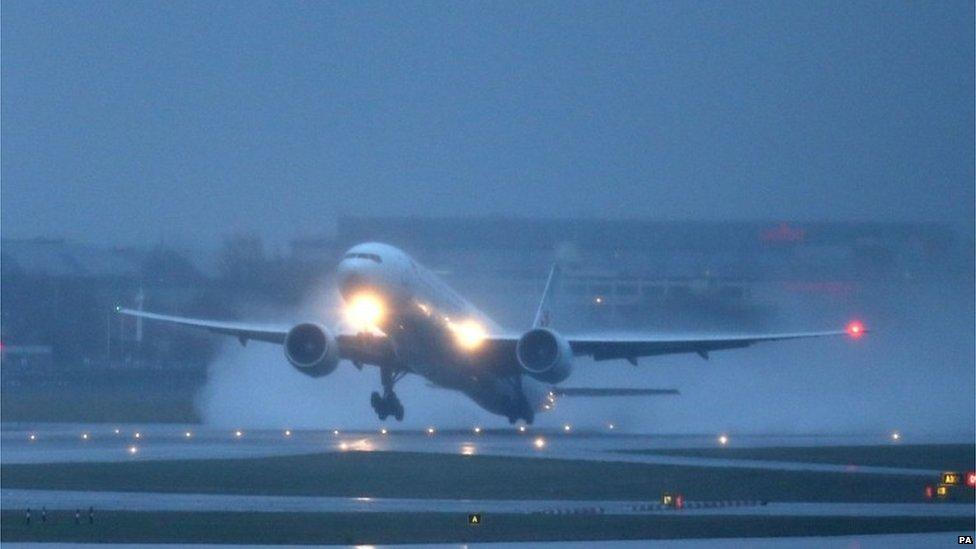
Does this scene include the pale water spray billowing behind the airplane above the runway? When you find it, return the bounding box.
[197,270,976,441]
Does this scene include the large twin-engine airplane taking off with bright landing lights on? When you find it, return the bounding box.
[116,242,867,424]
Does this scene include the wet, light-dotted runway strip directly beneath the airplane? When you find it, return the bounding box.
[0,424,952,477]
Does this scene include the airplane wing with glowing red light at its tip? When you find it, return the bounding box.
[569,325,867,364]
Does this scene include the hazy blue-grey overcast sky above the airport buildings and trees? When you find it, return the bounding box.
[0,0,976,244]
